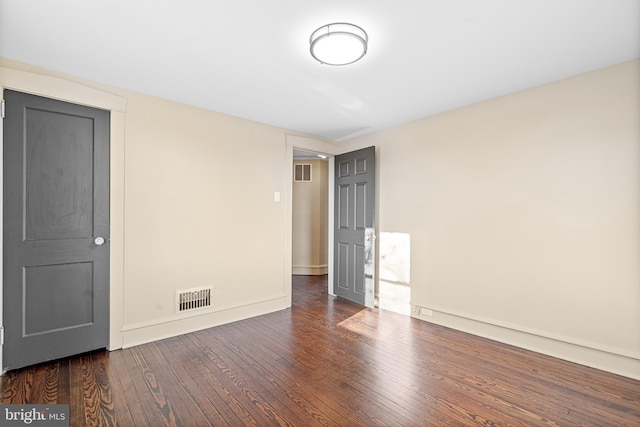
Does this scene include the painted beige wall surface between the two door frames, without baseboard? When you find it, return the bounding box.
[120,94,285,329]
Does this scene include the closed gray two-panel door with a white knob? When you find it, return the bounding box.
[3,90,110,370]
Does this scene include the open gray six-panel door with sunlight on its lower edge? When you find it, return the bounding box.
[333,147,376,307]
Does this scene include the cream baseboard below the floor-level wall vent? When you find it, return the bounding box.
[122,296,291,348]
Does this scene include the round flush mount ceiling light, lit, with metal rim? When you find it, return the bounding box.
[309,22,369,65]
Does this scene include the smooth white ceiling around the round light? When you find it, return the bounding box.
[0,0,640,141]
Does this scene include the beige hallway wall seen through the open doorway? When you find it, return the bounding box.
[292,160,329,275]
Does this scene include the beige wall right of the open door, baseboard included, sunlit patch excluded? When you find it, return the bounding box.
[344,61,640,377]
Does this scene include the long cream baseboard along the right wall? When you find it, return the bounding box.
[411,310,640,380]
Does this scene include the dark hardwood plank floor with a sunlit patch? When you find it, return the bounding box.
[0,276,640,427]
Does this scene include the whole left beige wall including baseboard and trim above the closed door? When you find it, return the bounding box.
[0,56,291,348]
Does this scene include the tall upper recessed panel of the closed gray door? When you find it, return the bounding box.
[24,109,93,240]
